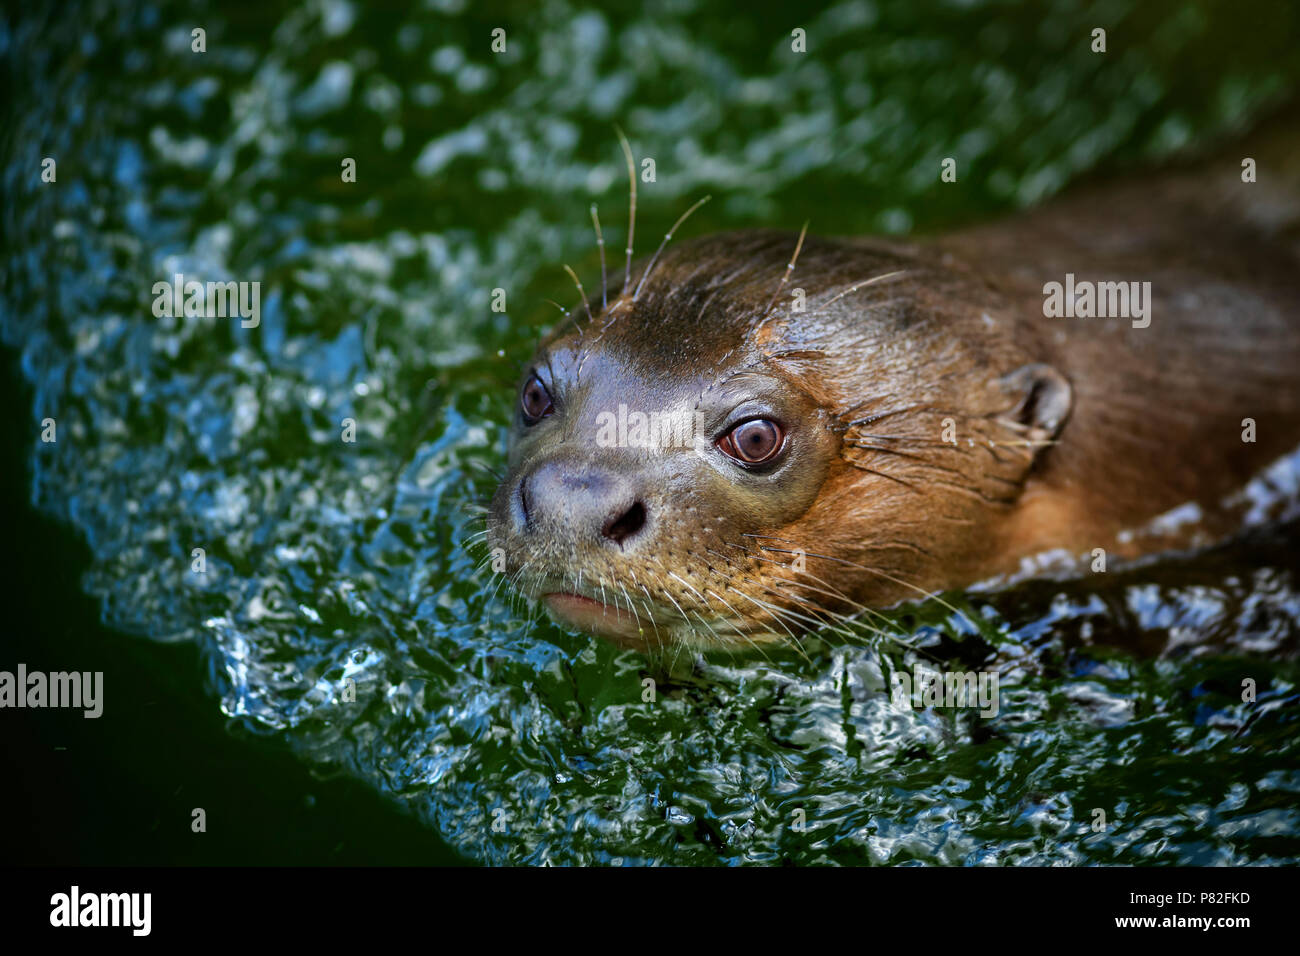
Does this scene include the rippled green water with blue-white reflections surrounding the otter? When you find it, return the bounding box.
[0,0,1300,865]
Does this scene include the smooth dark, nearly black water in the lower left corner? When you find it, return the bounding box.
[0,350,460,865]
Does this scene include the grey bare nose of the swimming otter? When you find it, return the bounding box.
[519,462,646,546]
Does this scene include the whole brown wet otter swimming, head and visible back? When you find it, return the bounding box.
[488,125,1300,652]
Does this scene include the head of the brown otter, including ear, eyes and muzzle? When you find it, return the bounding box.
[488,233,1069,650]
